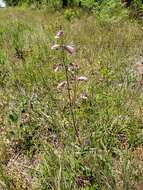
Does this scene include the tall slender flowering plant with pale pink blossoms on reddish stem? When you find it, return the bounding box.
[51,30,82,146]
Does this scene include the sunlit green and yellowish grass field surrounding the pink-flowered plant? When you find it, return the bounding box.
[0,8,143,190]
